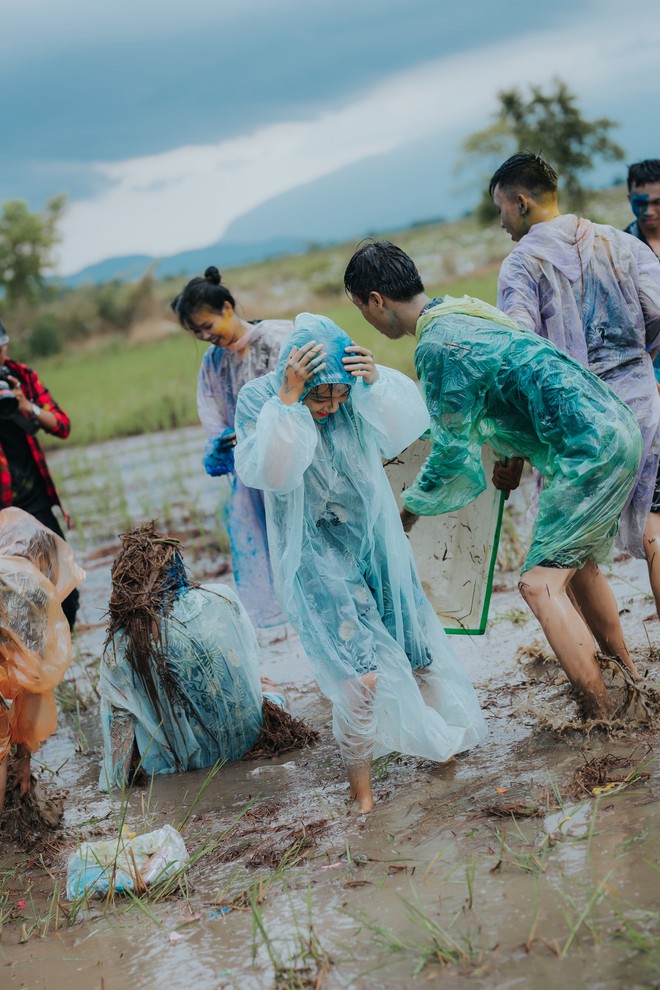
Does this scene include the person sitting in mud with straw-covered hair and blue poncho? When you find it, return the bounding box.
[99,523,297,790]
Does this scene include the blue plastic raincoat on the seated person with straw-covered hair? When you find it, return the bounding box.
[99,584,262,790]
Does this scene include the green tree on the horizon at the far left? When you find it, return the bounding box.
[0,195,66,310]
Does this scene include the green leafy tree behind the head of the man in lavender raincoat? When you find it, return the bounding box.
[462,79,625,220]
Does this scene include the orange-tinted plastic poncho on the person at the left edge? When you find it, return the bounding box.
[0,508,85,760]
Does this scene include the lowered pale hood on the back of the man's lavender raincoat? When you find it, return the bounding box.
[513,213,595,282]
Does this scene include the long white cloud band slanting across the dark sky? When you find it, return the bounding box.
[55,0,660,274]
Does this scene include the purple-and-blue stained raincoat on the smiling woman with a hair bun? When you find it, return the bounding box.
[197,320,293,628]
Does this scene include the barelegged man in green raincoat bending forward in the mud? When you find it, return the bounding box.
[344,241,642,717]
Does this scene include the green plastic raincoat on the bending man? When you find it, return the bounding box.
[403,296,642,571]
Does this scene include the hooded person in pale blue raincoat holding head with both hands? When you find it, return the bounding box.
[235,313,484,811]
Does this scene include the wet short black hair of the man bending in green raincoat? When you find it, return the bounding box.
[344,241,424,303]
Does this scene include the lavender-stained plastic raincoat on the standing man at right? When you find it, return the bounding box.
[498,214,660,557]
